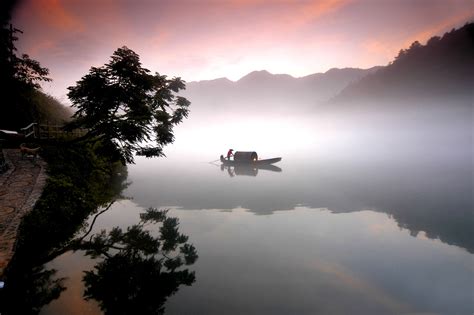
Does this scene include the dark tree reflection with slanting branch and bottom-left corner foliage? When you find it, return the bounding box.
[2,202,198,314]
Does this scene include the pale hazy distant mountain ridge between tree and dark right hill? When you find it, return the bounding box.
[182,67,379,115]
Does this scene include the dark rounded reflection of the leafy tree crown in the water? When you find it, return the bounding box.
[80,209,198,314]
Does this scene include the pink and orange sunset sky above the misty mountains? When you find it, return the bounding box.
[12,0,474,103]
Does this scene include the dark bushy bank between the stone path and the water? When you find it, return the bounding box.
[0,144,128,315]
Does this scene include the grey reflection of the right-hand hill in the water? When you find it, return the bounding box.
[333,158,474,253]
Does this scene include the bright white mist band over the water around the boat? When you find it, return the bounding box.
[130,97,473,238]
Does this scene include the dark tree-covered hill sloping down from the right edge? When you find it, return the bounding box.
[331,23,474,104]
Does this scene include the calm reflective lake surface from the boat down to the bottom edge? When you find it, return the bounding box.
[41,124,474,314]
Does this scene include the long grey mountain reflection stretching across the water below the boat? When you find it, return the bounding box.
[126,147,474,252]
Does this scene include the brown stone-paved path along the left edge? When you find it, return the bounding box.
[0,149,46,280]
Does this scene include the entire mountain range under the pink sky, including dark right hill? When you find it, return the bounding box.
[183,23,474,114]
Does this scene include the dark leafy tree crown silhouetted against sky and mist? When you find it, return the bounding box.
[66,46,190,163]
